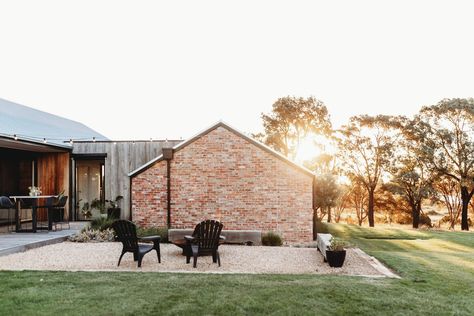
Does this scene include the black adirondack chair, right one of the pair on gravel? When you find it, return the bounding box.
[184,220,224,268]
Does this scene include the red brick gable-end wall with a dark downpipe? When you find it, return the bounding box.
[129,122,314,243]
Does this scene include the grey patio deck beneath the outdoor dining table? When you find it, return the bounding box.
[0,222,86,256]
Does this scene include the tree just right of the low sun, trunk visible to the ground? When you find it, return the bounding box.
[338,115,397,227]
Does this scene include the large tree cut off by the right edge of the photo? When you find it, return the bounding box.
[411,99,474,230]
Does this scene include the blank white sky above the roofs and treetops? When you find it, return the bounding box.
[0,0,474,140]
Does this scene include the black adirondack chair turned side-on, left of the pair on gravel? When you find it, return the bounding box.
[112,220,161,268]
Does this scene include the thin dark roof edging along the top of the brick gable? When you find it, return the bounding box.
[128,121,314,177]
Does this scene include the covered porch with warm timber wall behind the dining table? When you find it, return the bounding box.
[0,135,71,233]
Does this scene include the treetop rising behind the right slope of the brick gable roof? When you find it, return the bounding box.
[253,96,332,159]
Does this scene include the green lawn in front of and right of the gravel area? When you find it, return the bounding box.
[0,225,474,315]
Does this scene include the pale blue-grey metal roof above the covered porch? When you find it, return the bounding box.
[0,98,108,148]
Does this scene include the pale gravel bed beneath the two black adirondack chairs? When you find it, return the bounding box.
[0,242,383,276]
